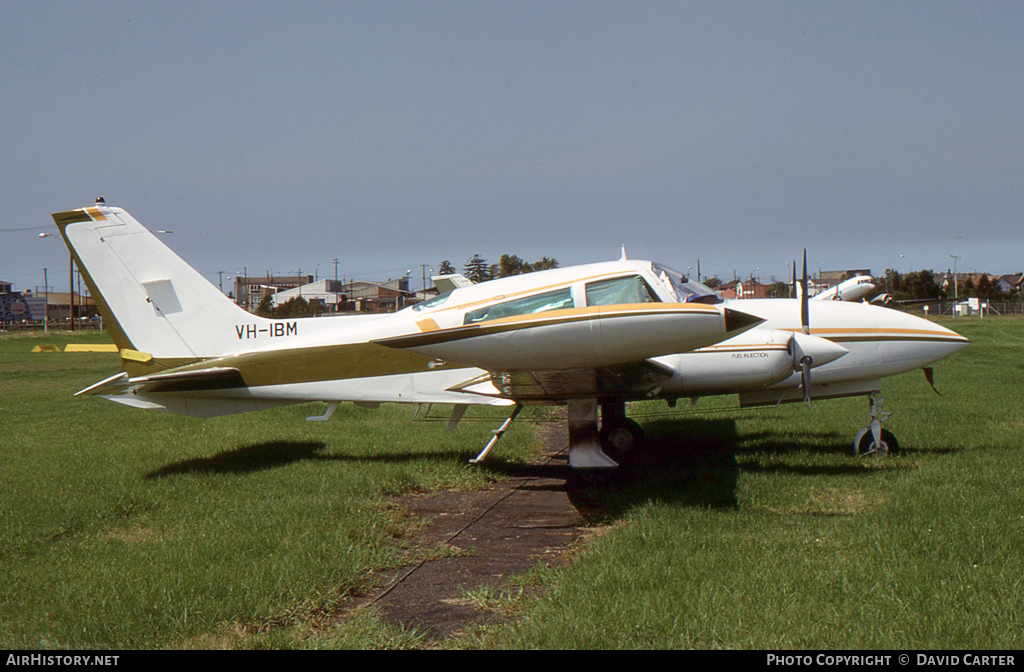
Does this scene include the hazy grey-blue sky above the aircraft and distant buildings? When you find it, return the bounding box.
[0,0,1024,289]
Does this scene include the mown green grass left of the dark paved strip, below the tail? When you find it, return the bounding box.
[0,327,538,648]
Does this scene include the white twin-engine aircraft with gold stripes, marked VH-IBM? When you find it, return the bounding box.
[53,199,969,468]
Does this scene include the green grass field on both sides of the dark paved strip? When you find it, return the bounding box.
[0,319,1024,648]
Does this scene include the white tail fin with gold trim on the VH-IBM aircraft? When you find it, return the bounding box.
[53,200,269,360]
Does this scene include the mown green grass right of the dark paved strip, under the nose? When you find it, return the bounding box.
[466,319,1024,649]
